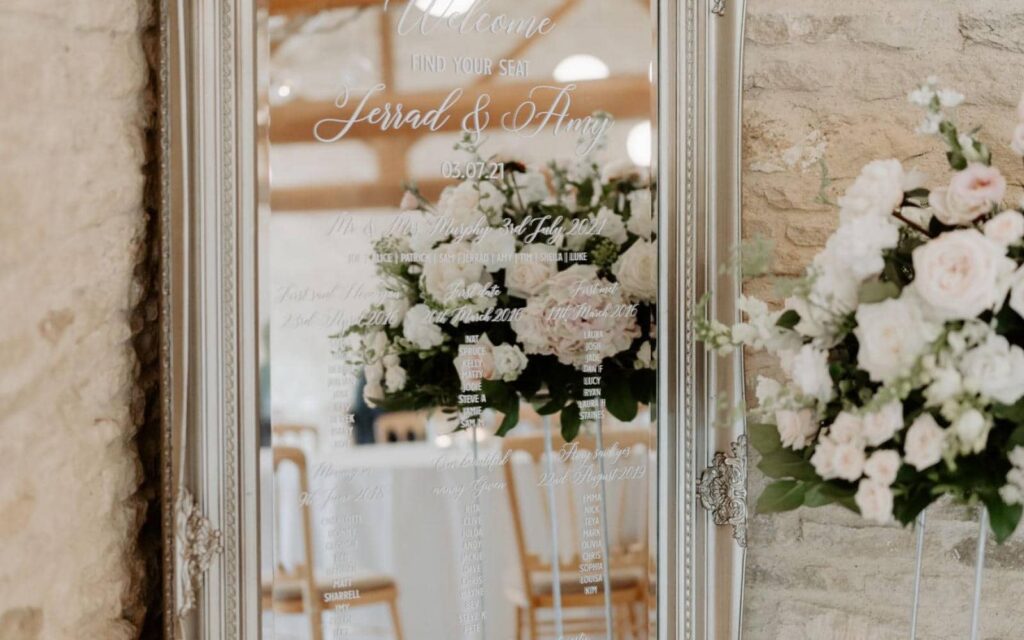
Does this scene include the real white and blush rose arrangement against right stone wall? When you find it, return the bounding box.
[698,79,1024,542]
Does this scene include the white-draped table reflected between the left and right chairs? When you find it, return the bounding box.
[266,439,520,640]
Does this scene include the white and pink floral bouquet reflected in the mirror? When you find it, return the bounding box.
[345,138,657,440]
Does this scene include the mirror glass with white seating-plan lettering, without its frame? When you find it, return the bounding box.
[259,0,658,640]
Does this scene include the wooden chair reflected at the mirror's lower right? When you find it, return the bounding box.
[504,429,652,640]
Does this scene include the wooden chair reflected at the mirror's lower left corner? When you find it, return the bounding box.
[262,446,402,640]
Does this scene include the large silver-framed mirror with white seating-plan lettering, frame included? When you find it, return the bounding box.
[160,0,748,640]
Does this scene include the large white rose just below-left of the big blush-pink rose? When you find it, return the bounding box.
[854,295,939,382]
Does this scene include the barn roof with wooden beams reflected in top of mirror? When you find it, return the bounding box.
[270,0,653,212]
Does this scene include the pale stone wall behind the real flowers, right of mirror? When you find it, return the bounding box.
[743,0,1024,640]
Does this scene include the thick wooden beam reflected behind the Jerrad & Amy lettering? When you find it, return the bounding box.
[270,76,651,144]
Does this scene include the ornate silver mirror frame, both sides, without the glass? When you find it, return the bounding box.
[160,0,746,640]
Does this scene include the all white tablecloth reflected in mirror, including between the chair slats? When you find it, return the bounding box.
[263,438,654,640]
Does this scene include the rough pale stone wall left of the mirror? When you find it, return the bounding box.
[0,0,154,640]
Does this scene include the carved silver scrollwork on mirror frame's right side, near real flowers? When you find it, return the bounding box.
[697,435,746,548]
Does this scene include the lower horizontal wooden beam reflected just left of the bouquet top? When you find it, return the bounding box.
[270,179,456,215]
